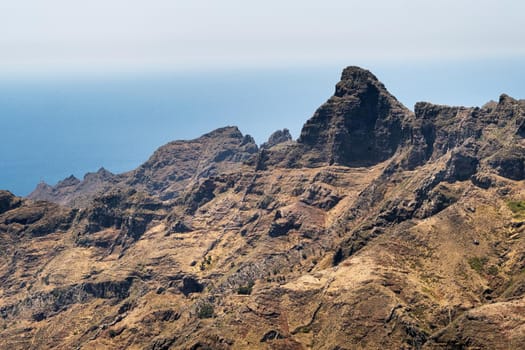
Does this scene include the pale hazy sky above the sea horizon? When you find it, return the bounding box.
[0,0,525,73]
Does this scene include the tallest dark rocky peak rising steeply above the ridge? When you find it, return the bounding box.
[298,67,411,166]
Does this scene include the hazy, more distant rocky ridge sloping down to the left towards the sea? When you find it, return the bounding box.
[28,127,258,208]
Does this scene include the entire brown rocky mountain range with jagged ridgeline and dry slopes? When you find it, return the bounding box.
[0,67,525,350]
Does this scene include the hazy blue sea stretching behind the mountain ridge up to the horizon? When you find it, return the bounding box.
[0,60,525,196]
